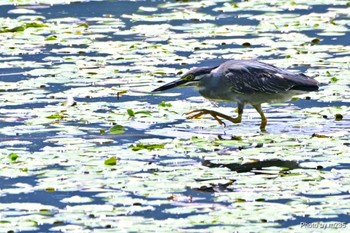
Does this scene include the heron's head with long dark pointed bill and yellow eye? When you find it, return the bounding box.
[152,67,213,92]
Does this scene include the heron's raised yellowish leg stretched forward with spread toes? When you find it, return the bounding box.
[186,104,244,125]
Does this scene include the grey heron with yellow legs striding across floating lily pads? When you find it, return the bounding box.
[152,60,319,131]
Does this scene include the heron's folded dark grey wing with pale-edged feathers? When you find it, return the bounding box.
[223,62,306,94]
